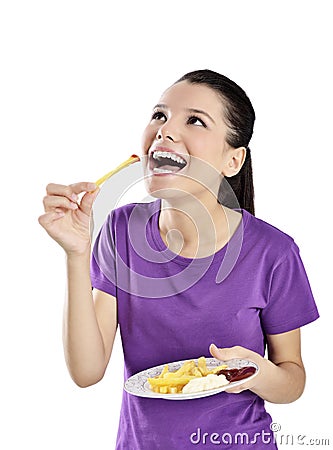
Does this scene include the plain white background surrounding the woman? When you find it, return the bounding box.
[0,0,333,450]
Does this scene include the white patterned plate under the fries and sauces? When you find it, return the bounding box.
[124,358,259,400]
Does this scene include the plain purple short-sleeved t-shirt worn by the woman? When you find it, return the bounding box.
[91,200,318,450]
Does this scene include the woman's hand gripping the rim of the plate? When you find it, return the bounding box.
[209,344,267,394]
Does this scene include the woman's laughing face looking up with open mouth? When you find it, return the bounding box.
[142,81,240,198]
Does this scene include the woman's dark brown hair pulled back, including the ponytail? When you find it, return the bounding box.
[176,69,255,215]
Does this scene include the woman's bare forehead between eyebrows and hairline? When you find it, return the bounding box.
[160,81,222,117]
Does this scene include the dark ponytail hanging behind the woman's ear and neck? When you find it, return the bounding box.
[218,148,255,216]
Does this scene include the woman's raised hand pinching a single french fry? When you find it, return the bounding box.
[38,182,99,255]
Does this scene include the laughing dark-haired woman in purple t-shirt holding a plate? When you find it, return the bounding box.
[39,70,318,450]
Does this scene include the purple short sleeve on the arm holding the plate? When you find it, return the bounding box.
[261,242,319,334]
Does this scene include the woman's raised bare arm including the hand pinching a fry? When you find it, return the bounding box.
[39,182,117,387]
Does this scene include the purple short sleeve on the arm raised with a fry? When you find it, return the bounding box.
[90,214,117,297]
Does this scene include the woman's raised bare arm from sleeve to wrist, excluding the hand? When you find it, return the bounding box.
[63,252,117,387]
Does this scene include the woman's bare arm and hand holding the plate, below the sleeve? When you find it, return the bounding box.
[210,329,305,403]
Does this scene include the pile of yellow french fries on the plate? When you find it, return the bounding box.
[148,356,228,394]
